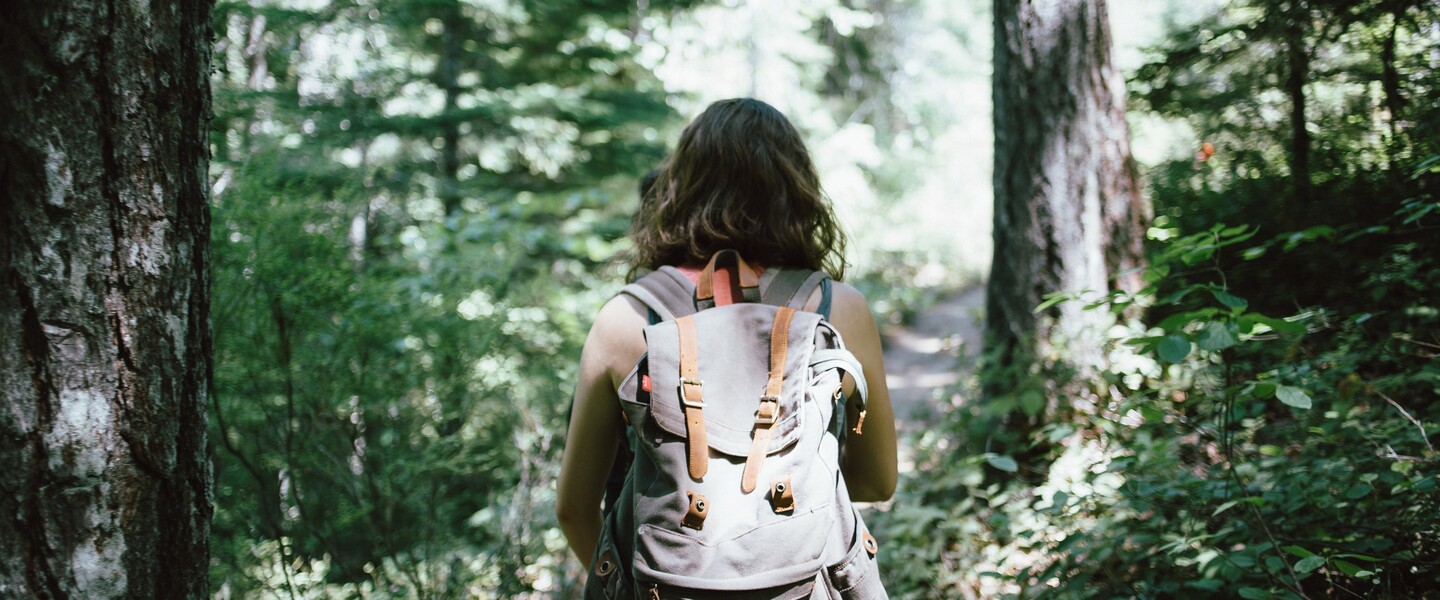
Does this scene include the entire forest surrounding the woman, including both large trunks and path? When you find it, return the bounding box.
[0,0,1440,592]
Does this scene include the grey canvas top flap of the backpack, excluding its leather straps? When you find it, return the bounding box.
[645,304,821,459]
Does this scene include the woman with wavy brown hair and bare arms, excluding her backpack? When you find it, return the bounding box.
[556,99,896,589]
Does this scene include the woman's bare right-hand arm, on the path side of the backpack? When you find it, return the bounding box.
[814,283,899,502]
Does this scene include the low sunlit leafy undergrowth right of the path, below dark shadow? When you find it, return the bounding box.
[877,185,1440,597]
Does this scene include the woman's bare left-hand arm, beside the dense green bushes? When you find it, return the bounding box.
[556,296,645,565]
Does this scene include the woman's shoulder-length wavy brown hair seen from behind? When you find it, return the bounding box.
[628,98,845,279]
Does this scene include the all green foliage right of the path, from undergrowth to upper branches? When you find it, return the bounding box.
[874,1,1440,589]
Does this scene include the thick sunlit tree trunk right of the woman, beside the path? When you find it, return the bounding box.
[985,0,1149,463]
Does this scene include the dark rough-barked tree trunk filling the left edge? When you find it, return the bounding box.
[0,0,212,599]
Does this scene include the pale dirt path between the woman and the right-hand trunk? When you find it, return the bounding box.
[883,283,985,473]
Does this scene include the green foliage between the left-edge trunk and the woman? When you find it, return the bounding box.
[212,1,691,597]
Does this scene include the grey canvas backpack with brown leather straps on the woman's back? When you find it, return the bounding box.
[585,250,887,600]
